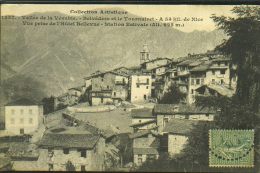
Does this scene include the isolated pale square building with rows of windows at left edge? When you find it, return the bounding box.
[5,99,43,134]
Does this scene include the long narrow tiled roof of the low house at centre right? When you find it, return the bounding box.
[154,104,216,114]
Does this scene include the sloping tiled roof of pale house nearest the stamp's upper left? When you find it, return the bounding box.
[163,118,199,135]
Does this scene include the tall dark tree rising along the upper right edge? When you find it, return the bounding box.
[212,6,260,111]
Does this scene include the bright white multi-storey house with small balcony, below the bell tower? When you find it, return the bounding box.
[130,74,152,102]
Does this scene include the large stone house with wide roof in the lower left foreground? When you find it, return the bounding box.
[38,126,105,171]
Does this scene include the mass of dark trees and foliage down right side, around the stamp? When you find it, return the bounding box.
[137,6,260,172]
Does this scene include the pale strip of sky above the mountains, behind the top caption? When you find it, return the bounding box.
[1,4,239,32]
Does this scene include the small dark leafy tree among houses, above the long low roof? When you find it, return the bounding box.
[159,84,186,104]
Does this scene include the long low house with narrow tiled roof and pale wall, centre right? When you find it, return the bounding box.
[154,104,216,133]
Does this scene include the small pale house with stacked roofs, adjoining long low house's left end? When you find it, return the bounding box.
[130,108,157,133]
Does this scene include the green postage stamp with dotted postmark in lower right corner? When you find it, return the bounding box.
[209,130,254,167]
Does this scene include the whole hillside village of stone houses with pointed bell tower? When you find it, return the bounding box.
[0,44,237,171]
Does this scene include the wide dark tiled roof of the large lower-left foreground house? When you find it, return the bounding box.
[39,133,99,149]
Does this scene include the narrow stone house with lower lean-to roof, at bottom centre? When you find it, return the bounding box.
[130,130,160,166]
